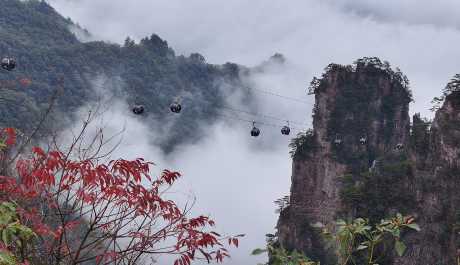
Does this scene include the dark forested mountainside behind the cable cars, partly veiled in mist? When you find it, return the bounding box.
[0,0,251,151]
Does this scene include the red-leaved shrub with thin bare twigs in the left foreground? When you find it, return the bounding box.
[0,122,243,265]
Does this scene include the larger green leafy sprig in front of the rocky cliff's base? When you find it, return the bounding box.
[315,214,420,265]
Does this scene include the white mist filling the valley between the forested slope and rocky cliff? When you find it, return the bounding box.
[59,77,291,265]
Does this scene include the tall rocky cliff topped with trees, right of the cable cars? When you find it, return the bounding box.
[278,58,460,265]
